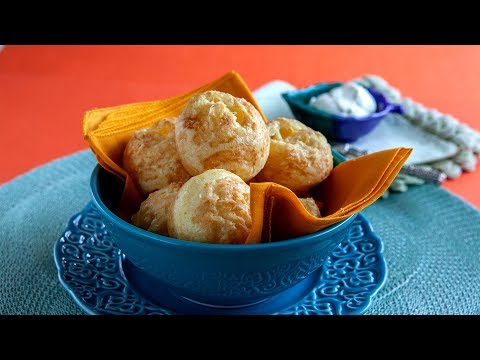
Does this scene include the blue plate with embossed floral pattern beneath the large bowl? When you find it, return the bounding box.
[54,204,387,315]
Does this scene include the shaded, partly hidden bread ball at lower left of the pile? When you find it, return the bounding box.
[132,183,182,236]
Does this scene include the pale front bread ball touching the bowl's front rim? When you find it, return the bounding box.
[168,169,252,244]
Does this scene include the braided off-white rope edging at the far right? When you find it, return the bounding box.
[354,75,480,179]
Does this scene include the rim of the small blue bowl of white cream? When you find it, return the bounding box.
[282,82,403,122]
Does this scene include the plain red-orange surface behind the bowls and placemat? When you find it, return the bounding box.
[0,45,480,208]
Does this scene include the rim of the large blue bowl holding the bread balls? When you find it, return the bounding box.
[90,150,357,251]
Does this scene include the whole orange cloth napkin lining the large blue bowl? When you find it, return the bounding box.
[83,71,412,244]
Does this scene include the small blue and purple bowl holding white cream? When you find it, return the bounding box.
[282,82,403,142]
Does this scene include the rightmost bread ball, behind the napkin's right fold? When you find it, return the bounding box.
[256,118,333,194]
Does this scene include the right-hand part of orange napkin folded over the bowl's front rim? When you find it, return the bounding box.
[245,148,412,244]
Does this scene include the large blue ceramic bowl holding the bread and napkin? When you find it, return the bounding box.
[90,153,356,307]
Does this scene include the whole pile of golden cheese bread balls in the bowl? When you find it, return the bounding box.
[123,91,333,244]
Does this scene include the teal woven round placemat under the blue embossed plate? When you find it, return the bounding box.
[0,151,480,314]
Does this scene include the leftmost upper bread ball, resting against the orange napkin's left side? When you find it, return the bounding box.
[123,118,190,195]
